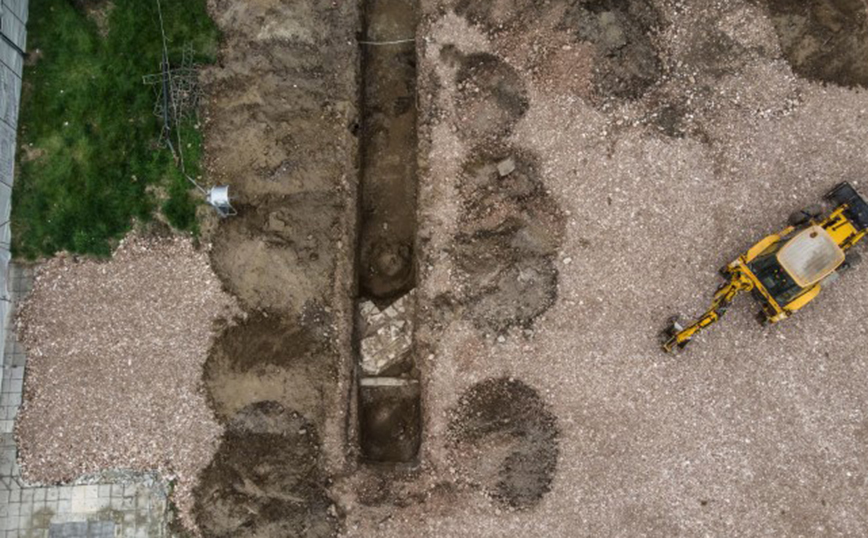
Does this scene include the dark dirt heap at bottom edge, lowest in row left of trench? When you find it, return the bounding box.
[195,402,337,538]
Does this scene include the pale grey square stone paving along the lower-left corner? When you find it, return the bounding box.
[0,264,169,538]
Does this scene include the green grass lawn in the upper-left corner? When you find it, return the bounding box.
[12,0,218,258]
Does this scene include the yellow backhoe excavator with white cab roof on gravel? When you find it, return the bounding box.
[663,182,868,352]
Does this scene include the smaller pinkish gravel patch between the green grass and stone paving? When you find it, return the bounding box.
[16,236,237,524]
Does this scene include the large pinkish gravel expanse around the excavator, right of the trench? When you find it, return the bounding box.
[346,1,868,538]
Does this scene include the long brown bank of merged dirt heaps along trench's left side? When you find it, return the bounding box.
[196,0,359,538]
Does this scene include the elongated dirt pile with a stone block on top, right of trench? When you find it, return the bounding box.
[455,145,564,332]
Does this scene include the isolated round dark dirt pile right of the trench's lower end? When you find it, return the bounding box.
[449,378,558,509]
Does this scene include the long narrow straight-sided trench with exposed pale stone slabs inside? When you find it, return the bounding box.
[356,0,421,463]
